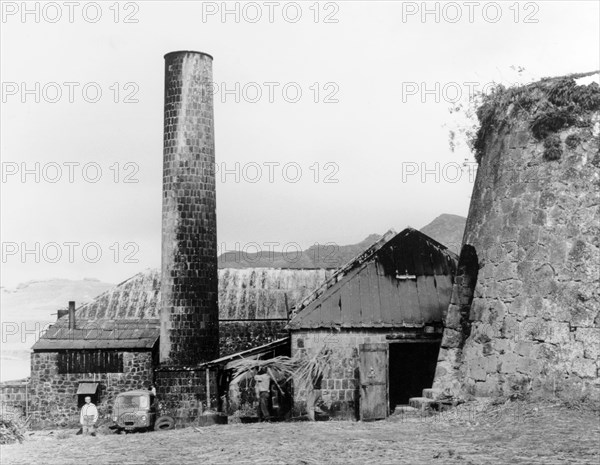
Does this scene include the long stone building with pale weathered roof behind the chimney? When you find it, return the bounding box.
[25,268,333,425]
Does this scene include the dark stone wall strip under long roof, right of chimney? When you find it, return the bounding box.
[219,320,289,357]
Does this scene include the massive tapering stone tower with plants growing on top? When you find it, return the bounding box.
[434,74,600,399]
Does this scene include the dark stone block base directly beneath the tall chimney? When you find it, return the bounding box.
[154,367,219,426]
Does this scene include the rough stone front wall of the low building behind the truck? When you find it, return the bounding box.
[29,351,153,426]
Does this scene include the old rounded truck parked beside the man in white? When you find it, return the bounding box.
[111,390,175,433]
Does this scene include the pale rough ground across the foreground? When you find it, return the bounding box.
[1,402,600,465]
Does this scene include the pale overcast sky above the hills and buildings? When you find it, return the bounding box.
[1,1,600,287]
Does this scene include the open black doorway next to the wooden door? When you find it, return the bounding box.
[389,340,441,412]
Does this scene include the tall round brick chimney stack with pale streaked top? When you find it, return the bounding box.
[160,51,219,366]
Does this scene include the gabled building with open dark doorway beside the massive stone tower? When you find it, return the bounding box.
[289,228,457,420]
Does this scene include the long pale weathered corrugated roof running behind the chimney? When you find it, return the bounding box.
[33,268,333,350]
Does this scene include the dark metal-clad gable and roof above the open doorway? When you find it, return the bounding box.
[289,228,458,329]
